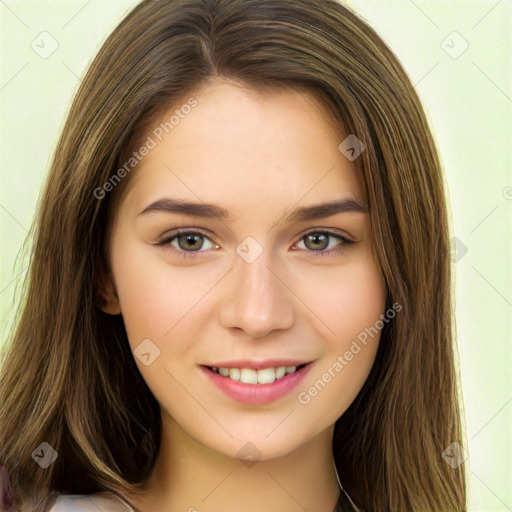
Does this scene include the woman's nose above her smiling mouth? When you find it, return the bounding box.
[220,251,295,338]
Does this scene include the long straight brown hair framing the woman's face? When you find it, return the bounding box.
[0,0,466,512]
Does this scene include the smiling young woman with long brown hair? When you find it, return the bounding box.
[0,0,466,512]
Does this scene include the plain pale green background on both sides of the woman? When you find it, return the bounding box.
[0,0,512,512]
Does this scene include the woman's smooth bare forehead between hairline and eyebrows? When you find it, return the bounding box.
[118,82,364,217]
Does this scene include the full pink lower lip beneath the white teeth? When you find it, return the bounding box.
[201,363,311,405]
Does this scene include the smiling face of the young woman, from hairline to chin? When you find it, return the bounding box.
[103,83,385,459]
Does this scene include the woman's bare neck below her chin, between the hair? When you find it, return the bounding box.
[129,413,339,512]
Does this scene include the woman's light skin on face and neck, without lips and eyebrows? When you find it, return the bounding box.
[100,81,386,512]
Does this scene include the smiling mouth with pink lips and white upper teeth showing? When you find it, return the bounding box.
[200,361,313,405]
